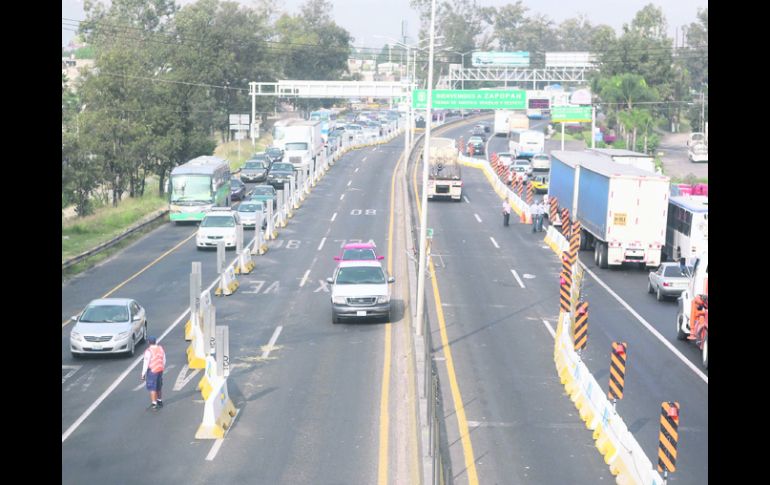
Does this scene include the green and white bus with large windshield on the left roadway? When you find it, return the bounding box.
[168,156,230,222]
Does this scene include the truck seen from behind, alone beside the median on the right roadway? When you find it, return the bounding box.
[428,137,463,202]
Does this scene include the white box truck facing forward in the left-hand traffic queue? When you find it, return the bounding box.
[273,118,324,175]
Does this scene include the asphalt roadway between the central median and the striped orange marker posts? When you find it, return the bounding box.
[410,115,613,485]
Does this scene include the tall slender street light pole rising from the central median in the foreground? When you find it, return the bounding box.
[415,0,436,335]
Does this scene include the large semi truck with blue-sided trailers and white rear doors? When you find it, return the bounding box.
[548,151,669,269]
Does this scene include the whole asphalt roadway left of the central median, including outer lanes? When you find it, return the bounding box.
[62,134,417,484]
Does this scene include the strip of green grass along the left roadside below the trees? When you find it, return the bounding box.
[61,182,168,261]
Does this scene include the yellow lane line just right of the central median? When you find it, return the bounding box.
[412,135,479,485]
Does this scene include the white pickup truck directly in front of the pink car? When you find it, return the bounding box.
[326,261,396,323]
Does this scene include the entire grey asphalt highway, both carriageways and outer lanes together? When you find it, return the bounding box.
[62,117,708,484]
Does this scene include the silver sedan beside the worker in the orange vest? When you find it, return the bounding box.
[70,298,147,358]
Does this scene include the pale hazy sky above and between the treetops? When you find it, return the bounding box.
[62,0,708,47]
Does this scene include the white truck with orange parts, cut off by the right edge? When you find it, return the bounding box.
[676,251,709,369]
